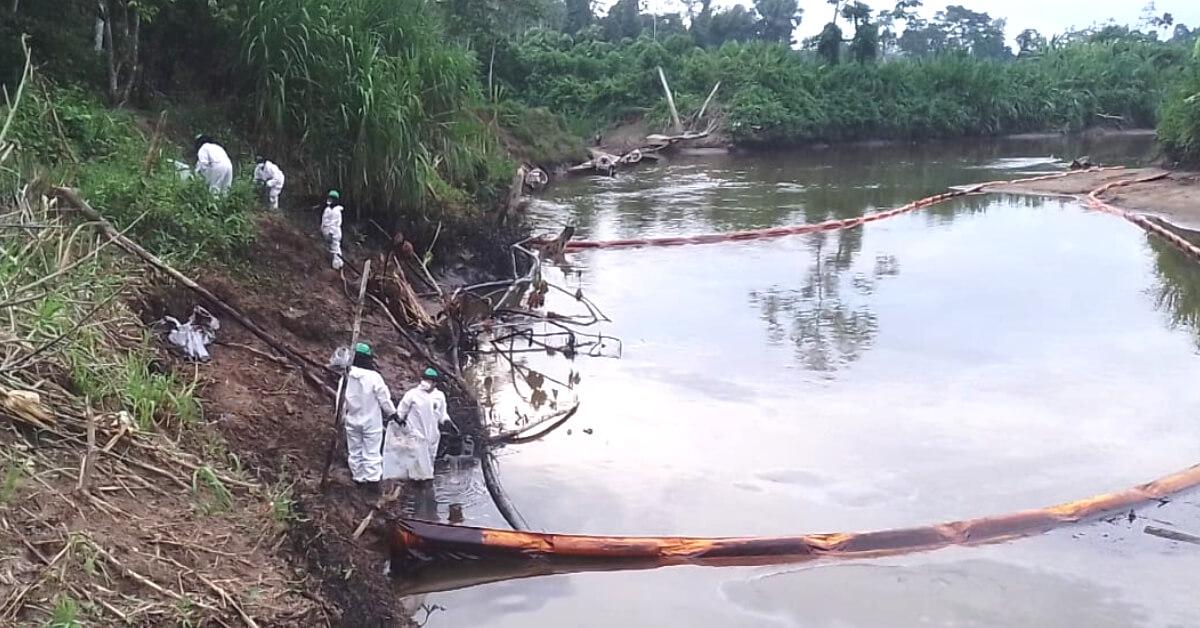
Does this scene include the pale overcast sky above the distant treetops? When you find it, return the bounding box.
[609,0,1200,40]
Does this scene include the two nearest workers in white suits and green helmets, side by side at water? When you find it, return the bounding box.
[344,342,457,494]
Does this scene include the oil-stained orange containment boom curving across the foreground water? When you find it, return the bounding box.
[392,465,1200,567]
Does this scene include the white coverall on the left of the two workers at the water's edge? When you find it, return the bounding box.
[346,366,396,482]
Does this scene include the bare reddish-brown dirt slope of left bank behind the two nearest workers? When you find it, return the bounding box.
[161,216,455,626]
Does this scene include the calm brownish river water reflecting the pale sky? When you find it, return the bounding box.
[400,138,1200,628]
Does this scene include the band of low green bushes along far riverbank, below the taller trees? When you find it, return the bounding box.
[497,31,1186,144]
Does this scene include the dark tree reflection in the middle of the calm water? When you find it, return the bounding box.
[750,228,900,373]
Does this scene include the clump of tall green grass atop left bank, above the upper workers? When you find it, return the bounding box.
[241,0,509,223]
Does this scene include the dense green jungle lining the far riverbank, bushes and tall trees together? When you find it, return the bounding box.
[472,0,1200,145]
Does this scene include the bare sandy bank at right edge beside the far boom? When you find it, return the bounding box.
[989,168,1200,231]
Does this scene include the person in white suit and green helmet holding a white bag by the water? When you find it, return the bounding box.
[385,367,458,480]
